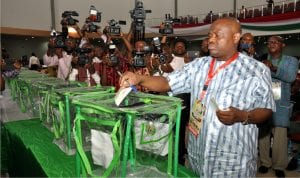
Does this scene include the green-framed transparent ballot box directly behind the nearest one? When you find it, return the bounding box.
[47,86,115,155]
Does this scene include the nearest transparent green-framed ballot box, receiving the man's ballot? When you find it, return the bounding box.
[72,92,181,177]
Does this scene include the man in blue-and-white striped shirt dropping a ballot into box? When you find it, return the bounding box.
[120,18,275,177]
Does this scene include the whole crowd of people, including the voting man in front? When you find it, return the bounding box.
[1,14,299,177]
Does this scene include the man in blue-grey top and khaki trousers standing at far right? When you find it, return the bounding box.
[259,36,299,177]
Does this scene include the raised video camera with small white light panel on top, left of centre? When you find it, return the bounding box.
[85,5,101,33]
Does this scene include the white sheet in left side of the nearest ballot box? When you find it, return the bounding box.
[91,129,114,168]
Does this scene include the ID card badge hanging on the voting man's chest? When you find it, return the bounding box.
[188,100,206,137]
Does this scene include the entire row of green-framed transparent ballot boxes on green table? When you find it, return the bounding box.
[9,70,195,177]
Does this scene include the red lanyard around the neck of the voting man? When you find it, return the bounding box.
[200,53,239,100]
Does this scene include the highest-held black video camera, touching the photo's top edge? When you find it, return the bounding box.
[130,1,152,30]
